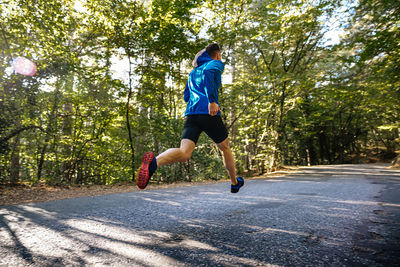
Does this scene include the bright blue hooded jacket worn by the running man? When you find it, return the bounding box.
[184,51,224,116]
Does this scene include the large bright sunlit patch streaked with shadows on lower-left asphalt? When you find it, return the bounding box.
[0,206,212,266]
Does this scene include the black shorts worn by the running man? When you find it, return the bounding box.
[182,114,228,144]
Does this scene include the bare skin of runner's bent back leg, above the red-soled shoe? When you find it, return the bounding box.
[156,139,196,166]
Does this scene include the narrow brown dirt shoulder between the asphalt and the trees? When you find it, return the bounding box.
[0,167,299,206]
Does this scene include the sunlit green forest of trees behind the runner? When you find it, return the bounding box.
[0,0,400,185]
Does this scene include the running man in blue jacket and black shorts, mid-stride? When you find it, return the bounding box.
[137,43,244,193]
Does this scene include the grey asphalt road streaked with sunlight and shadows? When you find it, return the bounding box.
[0,165,400,266]
